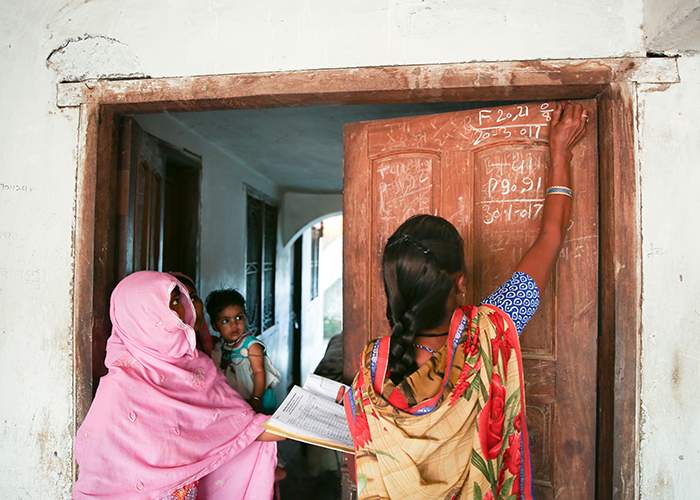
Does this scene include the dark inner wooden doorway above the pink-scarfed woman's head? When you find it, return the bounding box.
[117,117,202,283]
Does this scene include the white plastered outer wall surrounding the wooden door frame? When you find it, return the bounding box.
[0,0,700,499]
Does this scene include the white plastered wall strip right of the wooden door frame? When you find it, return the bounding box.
[638,56,700,499]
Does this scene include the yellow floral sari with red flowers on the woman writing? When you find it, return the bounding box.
[345,305,532,500]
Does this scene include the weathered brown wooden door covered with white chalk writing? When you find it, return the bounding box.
[344,100,598,499]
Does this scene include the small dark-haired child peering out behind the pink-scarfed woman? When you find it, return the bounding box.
[206,289,279,413]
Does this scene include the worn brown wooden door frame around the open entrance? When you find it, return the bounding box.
[64,58,679,498]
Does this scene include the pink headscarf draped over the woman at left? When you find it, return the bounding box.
[73,271,276,499]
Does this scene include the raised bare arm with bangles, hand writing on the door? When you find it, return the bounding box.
[515,103,588,291]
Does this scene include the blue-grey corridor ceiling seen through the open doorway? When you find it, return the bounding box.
[161,103,484,193]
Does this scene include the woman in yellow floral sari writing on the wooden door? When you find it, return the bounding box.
[345,104,587,500]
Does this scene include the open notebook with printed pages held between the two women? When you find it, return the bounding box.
[264,374,355,453]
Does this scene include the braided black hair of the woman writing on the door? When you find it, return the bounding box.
[382,215,464,384]
